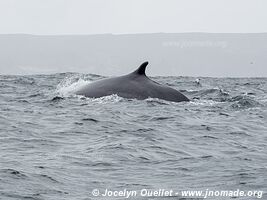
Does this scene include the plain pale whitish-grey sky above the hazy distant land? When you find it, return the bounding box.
[0,0,267,35]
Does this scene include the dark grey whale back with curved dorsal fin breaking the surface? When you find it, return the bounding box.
[75,62,189,102]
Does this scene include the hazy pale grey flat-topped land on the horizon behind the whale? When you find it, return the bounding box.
[0,33,267,77]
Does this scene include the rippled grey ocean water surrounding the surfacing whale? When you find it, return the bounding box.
[0,73,267,200]
